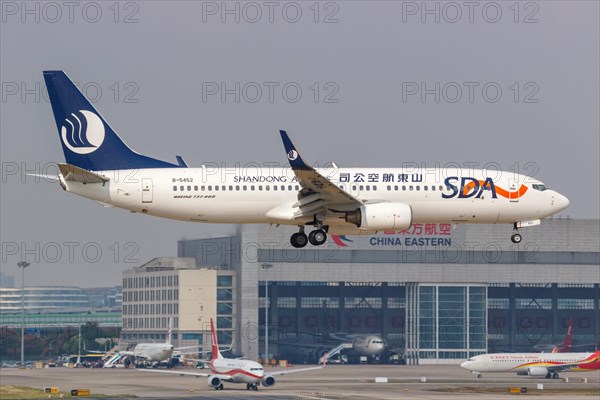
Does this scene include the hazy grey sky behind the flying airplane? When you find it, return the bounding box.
[0,1,600,287]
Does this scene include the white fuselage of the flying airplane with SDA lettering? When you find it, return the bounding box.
[61,168,568,234]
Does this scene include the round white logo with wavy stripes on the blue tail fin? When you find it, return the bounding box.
[60,110,105,154]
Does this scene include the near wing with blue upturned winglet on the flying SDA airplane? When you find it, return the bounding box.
[279,130,363,218]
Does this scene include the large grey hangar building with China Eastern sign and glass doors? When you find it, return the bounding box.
[171,218,600,363]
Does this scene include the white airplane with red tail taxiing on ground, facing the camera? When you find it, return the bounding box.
[142,318,324,390]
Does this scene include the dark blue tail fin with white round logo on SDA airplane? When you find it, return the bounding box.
[44,71,181,171]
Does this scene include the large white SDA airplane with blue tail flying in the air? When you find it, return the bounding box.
[44,71,569,248]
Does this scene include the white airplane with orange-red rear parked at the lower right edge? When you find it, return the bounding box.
[460,351,600,379]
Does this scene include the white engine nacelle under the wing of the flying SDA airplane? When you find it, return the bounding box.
[345,203,412,231]
